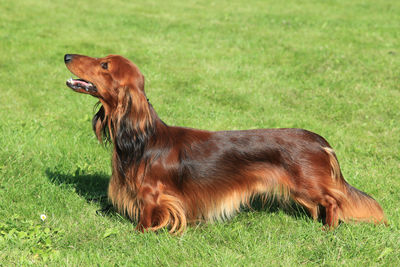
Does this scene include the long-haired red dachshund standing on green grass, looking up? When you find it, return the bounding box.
[64,54,385,232]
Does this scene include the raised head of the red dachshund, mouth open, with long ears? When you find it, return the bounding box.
[64,54,152,147]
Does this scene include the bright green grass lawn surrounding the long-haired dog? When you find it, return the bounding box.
[0,0,400,266]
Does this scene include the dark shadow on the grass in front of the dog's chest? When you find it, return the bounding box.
[46,169,116,216]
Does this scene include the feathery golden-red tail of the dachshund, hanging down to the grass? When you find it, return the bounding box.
[324,148,387,224]
